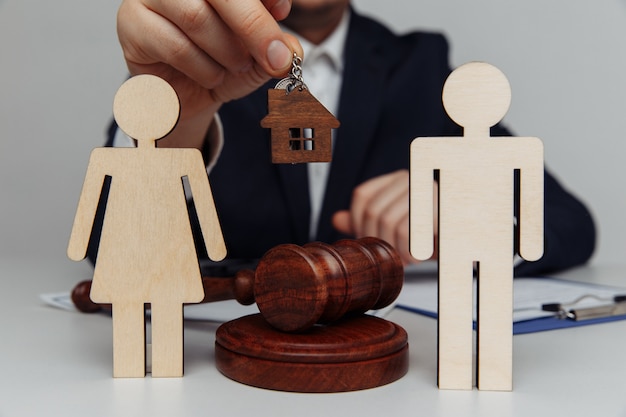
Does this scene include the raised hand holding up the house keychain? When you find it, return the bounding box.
[117,0,302,122]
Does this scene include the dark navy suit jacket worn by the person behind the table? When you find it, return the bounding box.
[103,8,595,274]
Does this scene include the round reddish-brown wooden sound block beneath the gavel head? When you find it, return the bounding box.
[215,314,409,392]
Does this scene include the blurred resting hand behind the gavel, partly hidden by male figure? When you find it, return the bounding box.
[332,170,437,264]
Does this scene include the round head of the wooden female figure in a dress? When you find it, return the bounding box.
[113,74,180,143]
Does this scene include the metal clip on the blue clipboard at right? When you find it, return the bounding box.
[541,294,626,321]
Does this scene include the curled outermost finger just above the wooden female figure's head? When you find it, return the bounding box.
[118,2,225,88]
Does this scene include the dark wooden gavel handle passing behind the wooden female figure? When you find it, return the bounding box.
[71,269,254,313]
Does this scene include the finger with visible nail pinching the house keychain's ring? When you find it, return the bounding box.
[210,0,301,76]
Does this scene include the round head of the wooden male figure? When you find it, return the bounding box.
[443,62,511,136]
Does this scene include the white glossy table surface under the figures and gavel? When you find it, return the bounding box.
[0,258,626,417]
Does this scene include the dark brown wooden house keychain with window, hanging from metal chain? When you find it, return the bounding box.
[261,53,339,164]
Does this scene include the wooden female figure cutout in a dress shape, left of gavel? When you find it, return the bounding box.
[68,75,226,377]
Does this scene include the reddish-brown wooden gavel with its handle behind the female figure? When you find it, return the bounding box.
[72,237,404,332]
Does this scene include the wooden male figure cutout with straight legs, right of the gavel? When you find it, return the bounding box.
[410,62,544,390]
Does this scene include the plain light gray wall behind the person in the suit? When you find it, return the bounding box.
[0,0,626,263]
